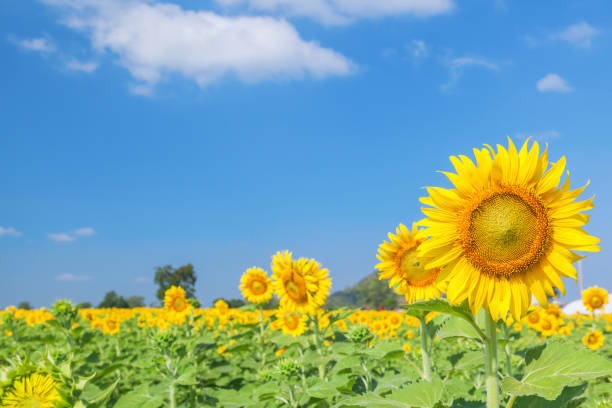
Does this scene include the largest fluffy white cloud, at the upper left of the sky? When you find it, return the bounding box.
[43,0,354,94]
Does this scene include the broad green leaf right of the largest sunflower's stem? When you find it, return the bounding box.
[502,343,612,400]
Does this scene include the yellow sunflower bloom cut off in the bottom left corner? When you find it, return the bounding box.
[1,373,61,408]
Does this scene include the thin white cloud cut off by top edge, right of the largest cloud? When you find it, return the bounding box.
[215,0,455,25]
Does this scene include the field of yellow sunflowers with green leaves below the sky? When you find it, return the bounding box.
[0,140,612,408]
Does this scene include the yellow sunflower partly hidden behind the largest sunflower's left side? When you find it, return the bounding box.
[376,224,440,303]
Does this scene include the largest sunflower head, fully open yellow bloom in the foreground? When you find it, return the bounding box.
[418,139,600,321]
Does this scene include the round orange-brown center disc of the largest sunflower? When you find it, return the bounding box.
[463,190,548,277]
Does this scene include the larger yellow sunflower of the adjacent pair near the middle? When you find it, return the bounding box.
[272,251,331,314]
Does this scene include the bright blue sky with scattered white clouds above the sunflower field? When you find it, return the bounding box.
[0,0,612,307]
